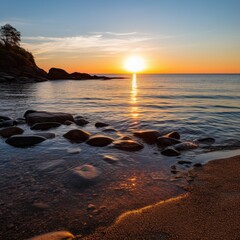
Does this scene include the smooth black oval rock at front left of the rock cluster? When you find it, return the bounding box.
[6,135,46,147]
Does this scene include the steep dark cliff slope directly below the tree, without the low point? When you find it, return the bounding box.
[0,45,47,80]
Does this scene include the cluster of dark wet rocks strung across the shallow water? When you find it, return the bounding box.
[0,110,215,156]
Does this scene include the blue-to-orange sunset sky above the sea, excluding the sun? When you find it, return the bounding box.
[0,0,240,73]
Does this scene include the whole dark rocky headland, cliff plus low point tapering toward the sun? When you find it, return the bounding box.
[0,42,122,83]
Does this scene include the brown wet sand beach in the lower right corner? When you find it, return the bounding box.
[84,155,240,240]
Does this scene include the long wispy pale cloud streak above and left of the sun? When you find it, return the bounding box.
[22,33,153,58]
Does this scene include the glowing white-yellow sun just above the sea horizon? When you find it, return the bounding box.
[124,55,146,73]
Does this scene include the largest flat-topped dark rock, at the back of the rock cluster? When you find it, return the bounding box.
[26,111,74,126]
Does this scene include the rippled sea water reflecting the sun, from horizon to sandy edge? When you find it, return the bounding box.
[0,75,240,239]
